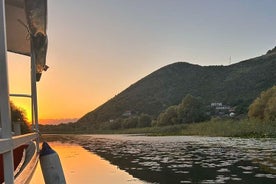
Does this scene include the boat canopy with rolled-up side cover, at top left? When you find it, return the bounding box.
[5,0,48,81]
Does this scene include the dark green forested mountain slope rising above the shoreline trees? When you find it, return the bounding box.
[77,48,276,126]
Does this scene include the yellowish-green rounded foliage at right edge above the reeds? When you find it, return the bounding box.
[248,86,276,121]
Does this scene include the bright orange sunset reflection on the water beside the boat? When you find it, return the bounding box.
[31,142,144,184]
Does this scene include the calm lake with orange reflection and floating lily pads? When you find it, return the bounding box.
[30,135,276,184]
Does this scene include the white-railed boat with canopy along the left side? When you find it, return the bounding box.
[0,0,48,184]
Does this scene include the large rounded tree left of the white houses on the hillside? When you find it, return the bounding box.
[177,95,208,123]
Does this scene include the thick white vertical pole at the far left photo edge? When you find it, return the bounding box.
[0,0,14,183]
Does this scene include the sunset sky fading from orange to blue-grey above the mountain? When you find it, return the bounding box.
[8,0,276,123]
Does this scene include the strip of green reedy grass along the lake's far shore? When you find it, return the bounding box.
[108,119,276,138]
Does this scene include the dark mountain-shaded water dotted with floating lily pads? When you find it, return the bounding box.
[43,135,276,184]
